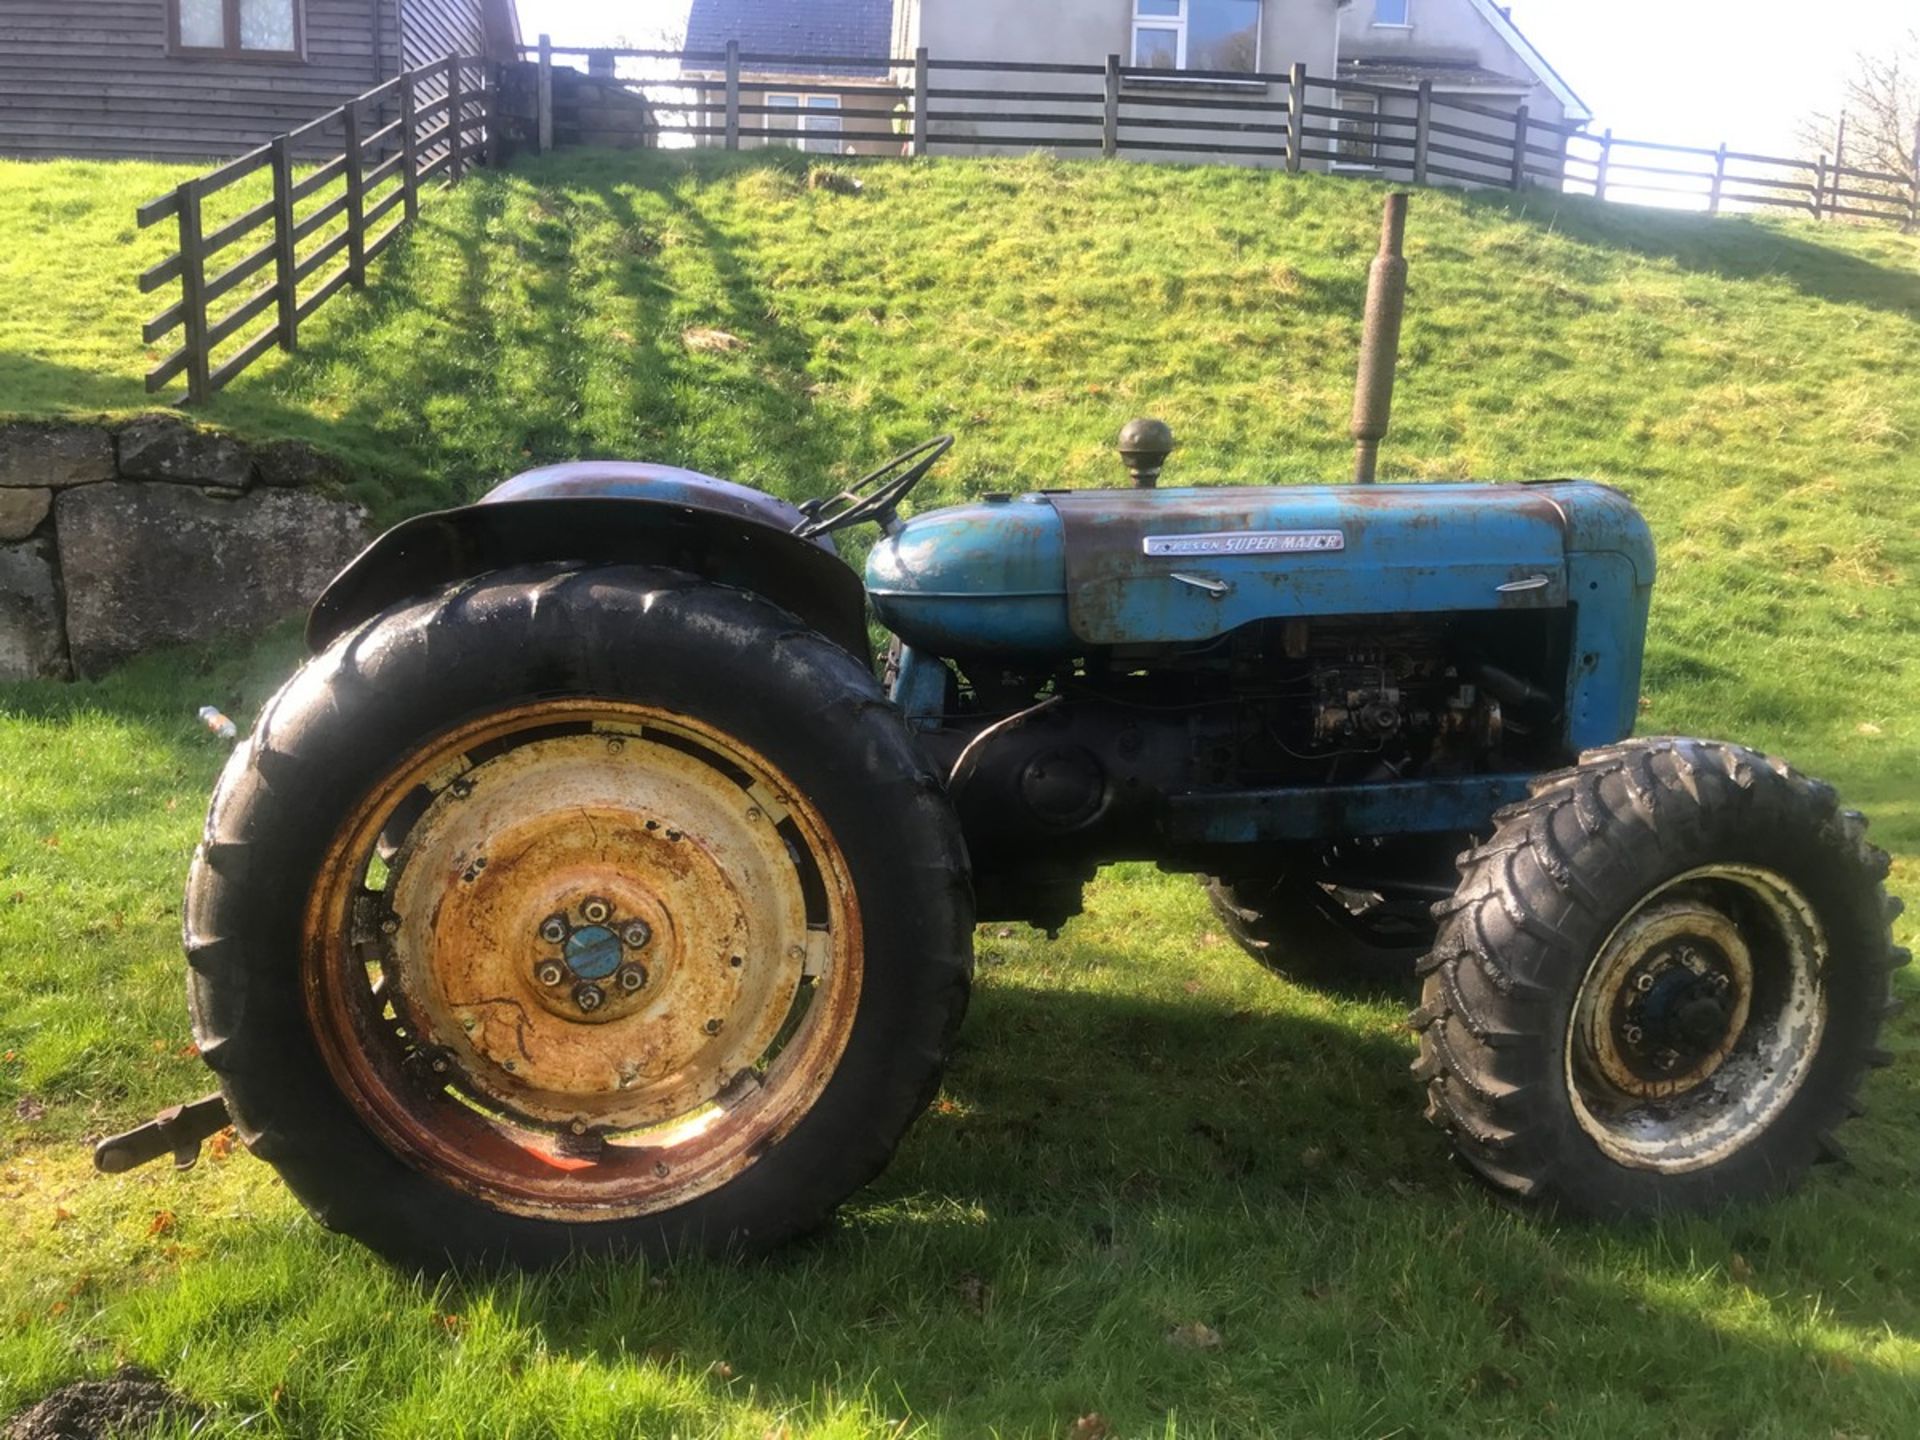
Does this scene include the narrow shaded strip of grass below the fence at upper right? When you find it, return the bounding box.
[1463,190,1920,317]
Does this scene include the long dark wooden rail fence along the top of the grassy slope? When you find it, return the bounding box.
[524,36,1920,228]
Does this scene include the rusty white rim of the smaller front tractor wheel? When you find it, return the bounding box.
[1565,864,1826,1173]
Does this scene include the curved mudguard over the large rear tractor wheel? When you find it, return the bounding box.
[307,461,872,659]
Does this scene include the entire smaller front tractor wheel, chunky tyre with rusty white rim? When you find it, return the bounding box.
[1413,739,1907,1217]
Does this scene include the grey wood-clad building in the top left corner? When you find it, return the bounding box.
[0,0,520,159]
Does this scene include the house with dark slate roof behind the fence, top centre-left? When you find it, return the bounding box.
[682,0,902,156]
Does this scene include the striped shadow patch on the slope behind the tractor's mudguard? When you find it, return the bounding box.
[205,154,858,520]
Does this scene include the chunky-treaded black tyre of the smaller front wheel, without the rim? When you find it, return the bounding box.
[1409,737,1908,1213]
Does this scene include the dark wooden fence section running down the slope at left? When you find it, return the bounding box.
[138,56,499,405]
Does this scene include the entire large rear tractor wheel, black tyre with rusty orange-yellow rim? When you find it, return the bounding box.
[186,566,972,1267]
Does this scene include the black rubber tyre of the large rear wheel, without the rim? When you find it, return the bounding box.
[182,564,972,1267]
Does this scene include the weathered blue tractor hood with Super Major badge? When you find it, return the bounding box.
[866,480,1653,655]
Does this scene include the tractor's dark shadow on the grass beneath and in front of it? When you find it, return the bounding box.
[459,966,1916,1434]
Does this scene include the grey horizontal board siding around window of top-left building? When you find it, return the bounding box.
[0,0,412,159]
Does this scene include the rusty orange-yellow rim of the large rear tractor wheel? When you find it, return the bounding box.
[301,701,862,1219]
